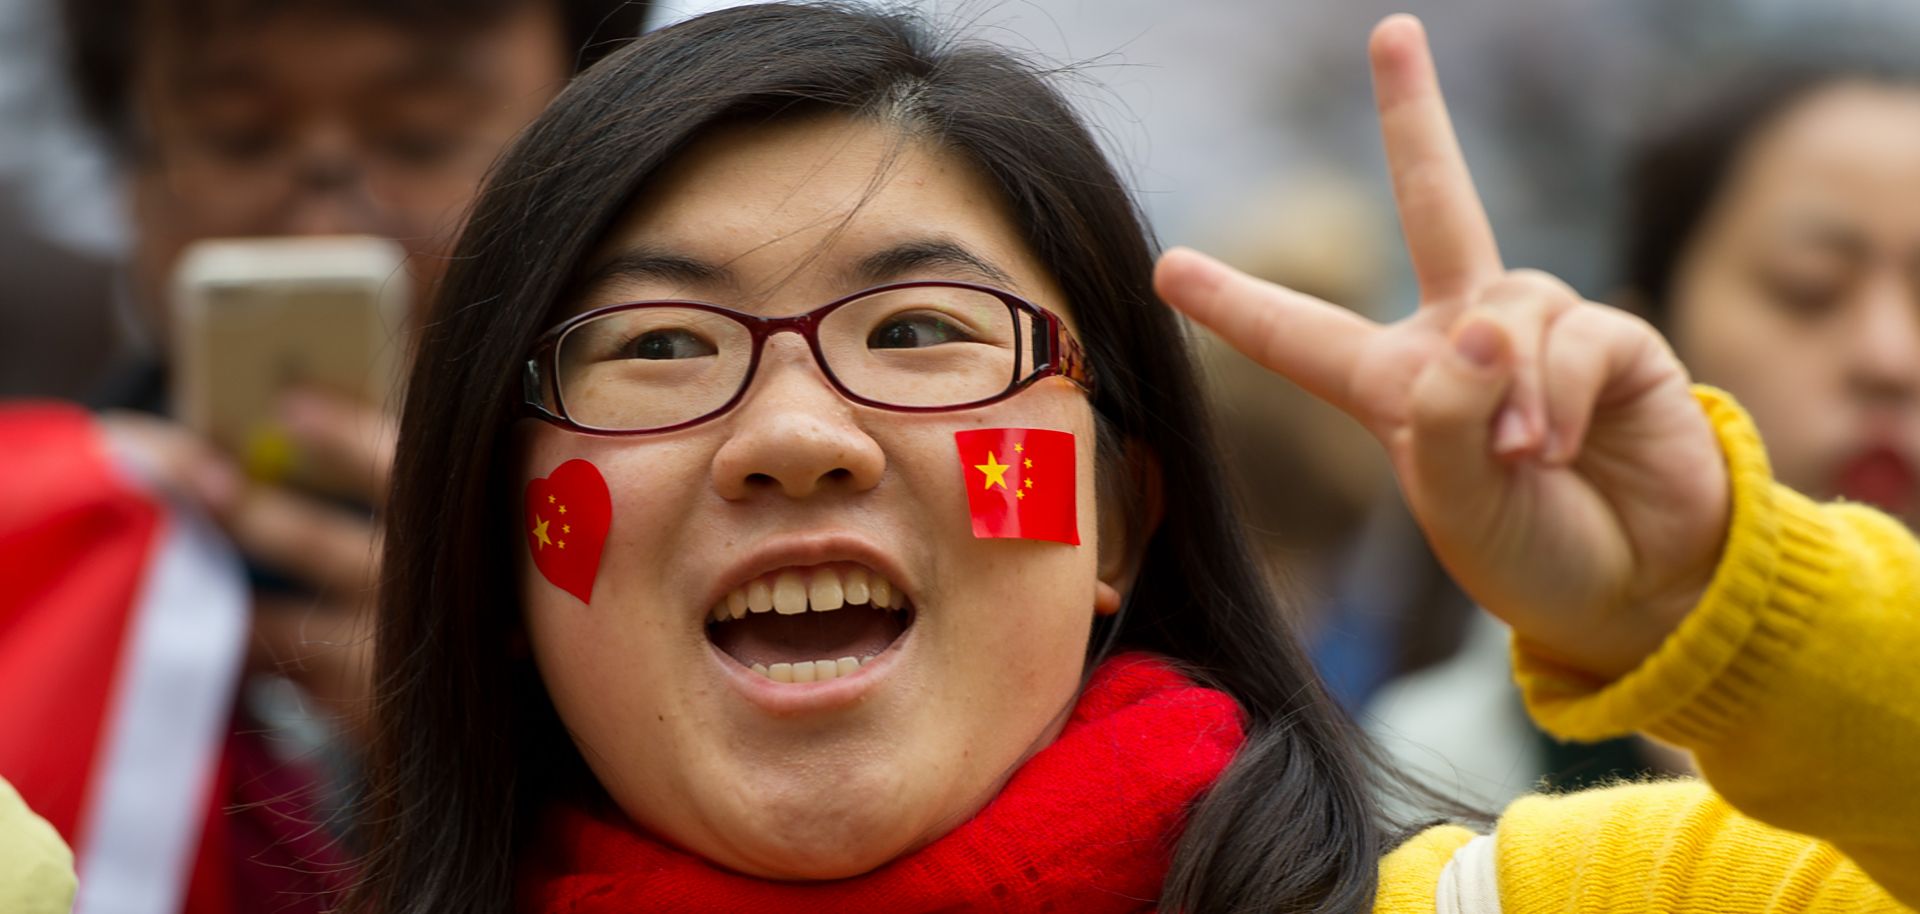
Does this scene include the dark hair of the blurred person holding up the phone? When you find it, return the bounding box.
[61,0,651,152]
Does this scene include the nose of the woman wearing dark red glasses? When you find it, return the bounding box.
[712,334,887,501]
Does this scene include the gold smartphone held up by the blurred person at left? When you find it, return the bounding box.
[171,236,413,495]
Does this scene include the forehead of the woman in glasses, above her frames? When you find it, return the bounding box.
[578,115,1058,307]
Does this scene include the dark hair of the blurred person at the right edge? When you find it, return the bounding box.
[1619,50,1920,330]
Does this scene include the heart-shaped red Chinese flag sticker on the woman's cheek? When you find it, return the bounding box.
[522,461,612,603]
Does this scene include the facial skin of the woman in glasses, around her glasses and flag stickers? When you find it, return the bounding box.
[520,115,1117,879]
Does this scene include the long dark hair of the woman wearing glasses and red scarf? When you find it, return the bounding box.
[348,4,1482,914]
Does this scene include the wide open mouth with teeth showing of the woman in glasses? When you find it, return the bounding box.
[707,563,914,682]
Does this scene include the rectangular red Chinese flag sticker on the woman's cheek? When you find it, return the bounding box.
[954,428,1079,545]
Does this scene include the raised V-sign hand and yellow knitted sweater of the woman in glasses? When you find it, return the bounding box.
[1160,17,1920,912]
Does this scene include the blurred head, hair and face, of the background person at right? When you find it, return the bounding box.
[1620,61,1920,526]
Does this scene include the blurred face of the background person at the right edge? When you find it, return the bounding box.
[1672,83,1920,522]
